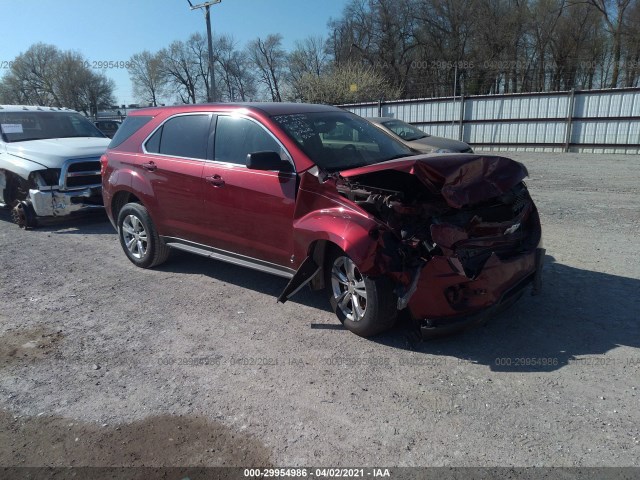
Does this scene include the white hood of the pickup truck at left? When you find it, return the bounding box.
[5,137,111,168]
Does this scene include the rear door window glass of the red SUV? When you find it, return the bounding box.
[144,114,211,160]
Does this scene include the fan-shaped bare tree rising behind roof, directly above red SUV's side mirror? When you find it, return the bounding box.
[247,33,287,102]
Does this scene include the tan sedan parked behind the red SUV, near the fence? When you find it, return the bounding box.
[367,117,473,153]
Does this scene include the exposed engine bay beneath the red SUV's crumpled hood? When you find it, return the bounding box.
[337,171,540,279]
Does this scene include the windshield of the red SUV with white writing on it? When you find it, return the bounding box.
[273,112,415,172]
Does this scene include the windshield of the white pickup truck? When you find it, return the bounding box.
[0,111,105,142]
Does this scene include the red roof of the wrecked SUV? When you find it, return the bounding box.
[129,102,344,116]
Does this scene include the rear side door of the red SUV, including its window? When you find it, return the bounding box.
[139,113,213,242]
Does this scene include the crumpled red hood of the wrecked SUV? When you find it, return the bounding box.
[340,153,528,208]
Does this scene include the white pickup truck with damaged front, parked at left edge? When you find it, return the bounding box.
[0,105,110,228]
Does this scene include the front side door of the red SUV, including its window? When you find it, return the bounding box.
[203,114,297,267]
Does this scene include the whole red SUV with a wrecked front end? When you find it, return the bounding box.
[101,103,544,336]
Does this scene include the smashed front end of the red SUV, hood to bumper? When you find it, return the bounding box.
[336,156,544,336]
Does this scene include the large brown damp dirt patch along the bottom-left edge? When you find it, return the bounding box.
[0,411,271,467]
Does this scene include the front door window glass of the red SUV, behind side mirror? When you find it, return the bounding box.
[214,116,289,165]
